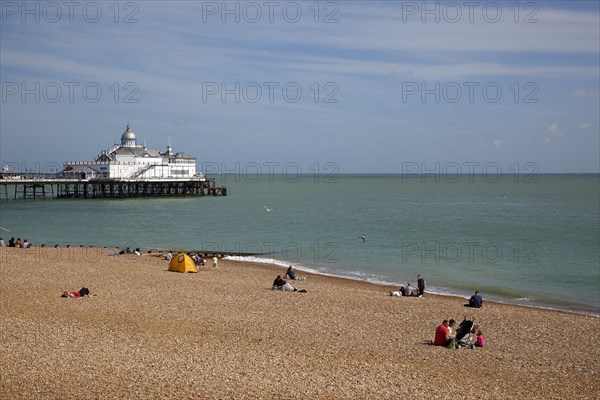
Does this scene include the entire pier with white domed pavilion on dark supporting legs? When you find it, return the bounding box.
[0,123,227,200]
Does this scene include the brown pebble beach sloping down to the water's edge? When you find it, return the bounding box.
[0,247,600,399]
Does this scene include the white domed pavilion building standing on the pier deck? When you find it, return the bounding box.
[63,124,203,180]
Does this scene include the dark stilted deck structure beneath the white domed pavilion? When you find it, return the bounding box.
[0,176,227,200]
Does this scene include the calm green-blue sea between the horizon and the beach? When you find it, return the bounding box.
[0,173,600,316]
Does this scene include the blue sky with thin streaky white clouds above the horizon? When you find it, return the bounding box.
[0,0,600,174]
